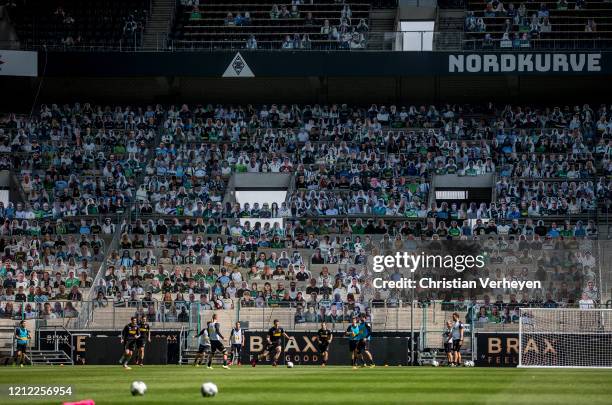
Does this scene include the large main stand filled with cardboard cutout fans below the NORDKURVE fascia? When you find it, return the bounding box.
[0,103,611,344]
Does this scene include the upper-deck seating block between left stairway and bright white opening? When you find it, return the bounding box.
[173,0,371,50]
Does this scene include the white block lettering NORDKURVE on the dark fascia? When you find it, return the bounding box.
[448,53,601,73]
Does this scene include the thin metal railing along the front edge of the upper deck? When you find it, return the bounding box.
[5,27,612,52]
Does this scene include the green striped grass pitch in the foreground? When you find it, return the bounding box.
[0,366,612,405]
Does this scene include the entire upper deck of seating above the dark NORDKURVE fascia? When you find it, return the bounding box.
[0,0,612,52]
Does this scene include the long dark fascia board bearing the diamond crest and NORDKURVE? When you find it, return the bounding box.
[39,51,612,76]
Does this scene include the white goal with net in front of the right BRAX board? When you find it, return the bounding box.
[518,308,612,368]
